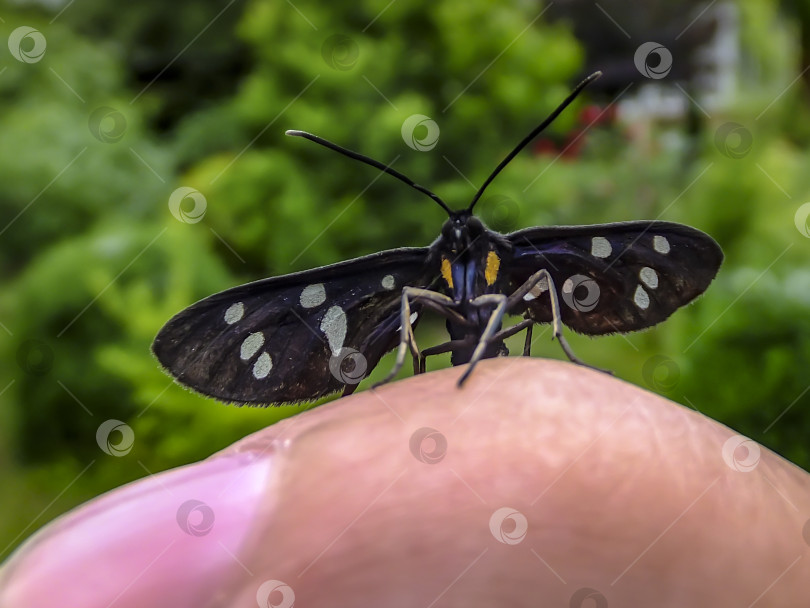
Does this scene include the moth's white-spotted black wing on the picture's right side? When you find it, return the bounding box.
[507,221,723,335]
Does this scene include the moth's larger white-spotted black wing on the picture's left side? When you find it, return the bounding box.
[152,248,430,404]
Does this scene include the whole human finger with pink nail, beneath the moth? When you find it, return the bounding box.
[0,358,810,608]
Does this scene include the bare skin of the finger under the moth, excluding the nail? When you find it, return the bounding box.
[226,358,810,607]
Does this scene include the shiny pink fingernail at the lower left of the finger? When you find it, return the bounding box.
[0,453,277,608]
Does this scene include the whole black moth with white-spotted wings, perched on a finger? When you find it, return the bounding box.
[152,72,723,404]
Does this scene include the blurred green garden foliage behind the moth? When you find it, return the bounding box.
[0,0,810,555]
